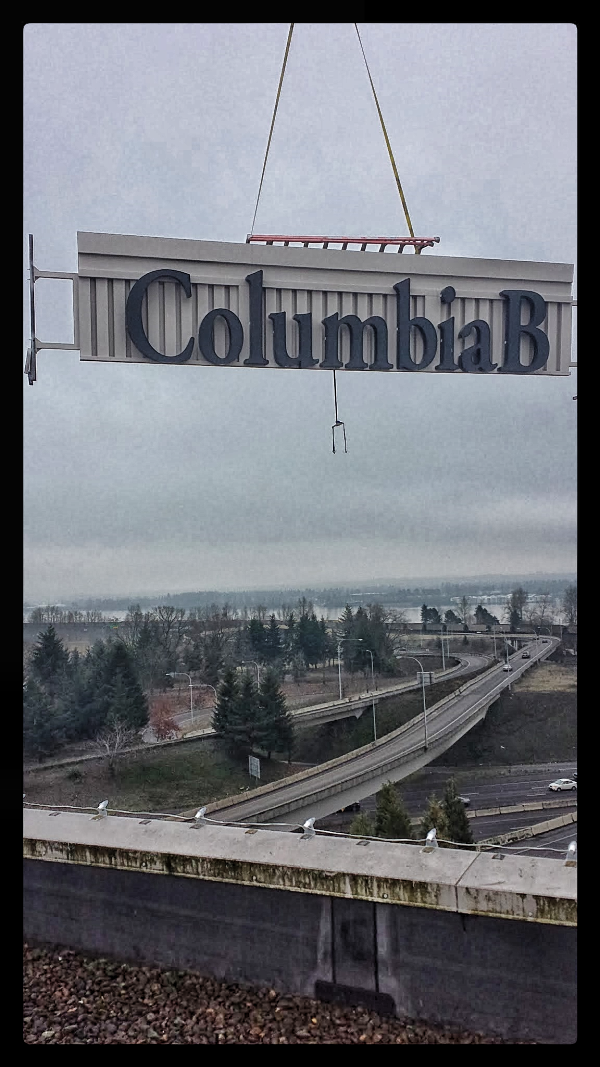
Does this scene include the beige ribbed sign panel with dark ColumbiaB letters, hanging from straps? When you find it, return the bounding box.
[76,233,573,375]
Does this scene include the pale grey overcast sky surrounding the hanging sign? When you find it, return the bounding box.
[23,22,577,603]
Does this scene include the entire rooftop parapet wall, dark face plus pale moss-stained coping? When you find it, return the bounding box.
[23,808,577,1044]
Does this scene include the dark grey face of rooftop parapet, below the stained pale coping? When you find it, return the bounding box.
[25,859,577,1044]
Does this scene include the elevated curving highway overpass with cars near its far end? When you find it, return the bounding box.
[197,638,558,824]
